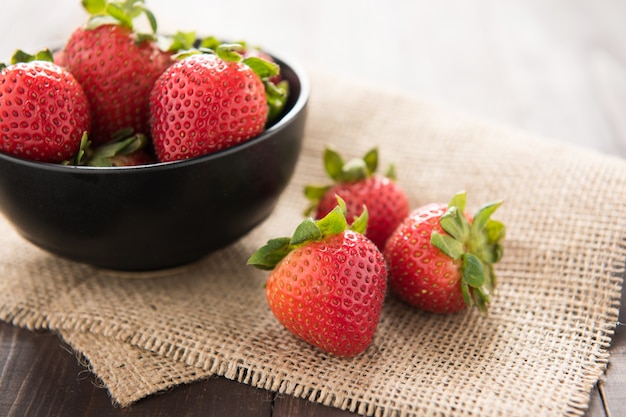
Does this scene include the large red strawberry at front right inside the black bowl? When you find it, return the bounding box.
[150,44,286,162]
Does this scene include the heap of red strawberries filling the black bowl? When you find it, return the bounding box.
[0,0,288,166]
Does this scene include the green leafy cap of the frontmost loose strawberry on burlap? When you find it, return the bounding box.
[248,196,368,270]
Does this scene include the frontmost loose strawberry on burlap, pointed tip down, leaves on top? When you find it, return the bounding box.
[248,199,387,357]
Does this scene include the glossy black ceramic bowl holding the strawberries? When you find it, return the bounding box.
[0,53,310,271]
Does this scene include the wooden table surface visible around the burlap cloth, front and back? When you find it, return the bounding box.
[0,0,626,417]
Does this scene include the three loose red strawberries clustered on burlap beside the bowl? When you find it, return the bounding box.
[248,149,505,357]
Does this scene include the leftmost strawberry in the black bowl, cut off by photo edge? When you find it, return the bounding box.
[0,51,91,163]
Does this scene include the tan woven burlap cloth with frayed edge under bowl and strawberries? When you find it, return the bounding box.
[0,73,626,416]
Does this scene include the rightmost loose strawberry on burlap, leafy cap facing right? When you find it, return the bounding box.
[384,192,505,313]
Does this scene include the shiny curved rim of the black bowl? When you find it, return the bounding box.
[0,53,311,174]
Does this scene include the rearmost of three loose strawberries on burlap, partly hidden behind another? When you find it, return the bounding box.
[304,148,410,250]
